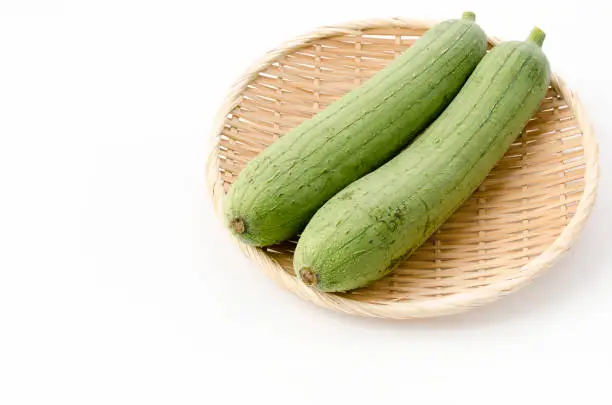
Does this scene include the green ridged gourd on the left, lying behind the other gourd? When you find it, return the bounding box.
[225,13,486,246]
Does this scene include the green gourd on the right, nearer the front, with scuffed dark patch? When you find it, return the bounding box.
[294,28,549,292]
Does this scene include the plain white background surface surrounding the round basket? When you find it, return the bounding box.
[0,0,612,405]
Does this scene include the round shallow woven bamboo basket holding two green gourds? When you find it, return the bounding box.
[207,19,598,319]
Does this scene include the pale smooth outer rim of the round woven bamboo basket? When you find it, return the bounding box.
[206,18,599,319]
